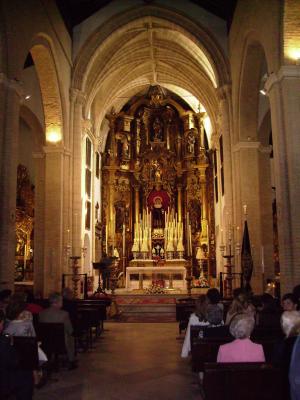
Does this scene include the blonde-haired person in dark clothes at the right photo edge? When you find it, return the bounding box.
[272,310,300,400]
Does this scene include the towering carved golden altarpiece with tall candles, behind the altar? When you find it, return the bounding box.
[102,86,215,288]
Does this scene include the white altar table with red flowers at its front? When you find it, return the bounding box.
[126,259,186,290]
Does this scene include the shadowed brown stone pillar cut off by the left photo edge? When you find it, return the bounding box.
[0,73,22,290]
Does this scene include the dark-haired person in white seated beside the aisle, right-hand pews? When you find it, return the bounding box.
[181,294,209,358]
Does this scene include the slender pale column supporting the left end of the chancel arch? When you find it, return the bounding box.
[70,89,85,256]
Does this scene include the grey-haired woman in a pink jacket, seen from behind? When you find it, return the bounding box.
[217,314,265,363]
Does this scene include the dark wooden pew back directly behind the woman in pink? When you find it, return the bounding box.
[203,363,284,400]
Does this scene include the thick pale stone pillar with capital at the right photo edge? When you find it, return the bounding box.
[265,65,300,293]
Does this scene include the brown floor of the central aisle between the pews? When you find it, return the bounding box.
[34,322,201,400]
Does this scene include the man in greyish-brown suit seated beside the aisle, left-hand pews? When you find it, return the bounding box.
[39,292,76,369]
